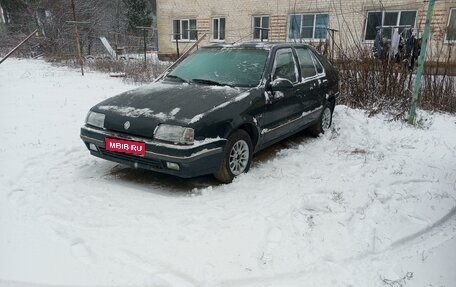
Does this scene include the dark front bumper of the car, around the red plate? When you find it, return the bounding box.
[81,126,226,178]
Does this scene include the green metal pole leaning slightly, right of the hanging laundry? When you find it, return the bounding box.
[408,0,435,125]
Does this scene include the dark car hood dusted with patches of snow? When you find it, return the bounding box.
[91,81,251,137]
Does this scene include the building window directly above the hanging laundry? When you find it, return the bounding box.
[364,11,416,41]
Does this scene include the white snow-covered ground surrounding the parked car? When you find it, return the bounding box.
[0,59,456,287]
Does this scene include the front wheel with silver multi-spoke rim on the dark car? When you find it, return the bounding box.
[214,130,253,183]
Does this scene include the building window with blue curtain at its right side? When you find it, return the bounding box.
[288,13,329,40]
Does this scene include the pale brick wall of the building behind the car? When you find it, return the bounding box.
[157,0,456,59]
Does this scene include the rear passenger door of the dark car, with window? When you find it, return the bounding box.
[295,46,327,124]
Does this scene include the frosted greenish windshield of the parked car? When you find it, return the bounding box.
[167,48,269,87]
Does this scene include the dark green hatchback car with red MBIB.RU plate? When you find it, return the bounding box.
[81,43,339,182]
